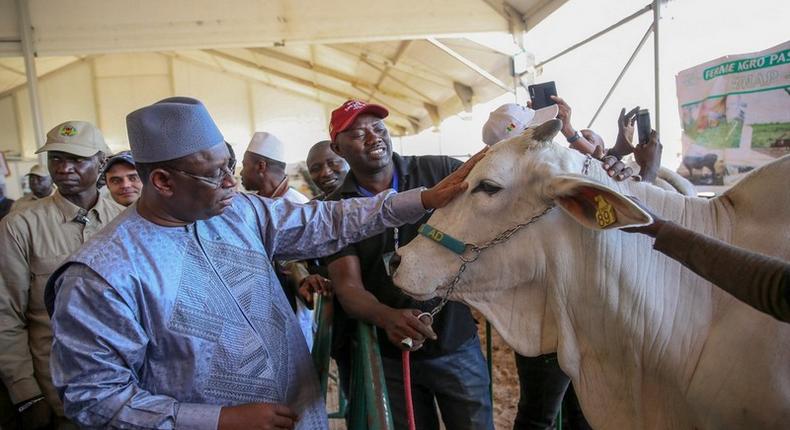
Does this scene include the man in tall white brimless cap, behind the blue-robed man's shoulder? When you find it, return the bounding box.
[241,131,310,203]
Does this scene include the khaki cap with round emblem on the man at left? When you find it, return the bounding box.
[36,121,110,157]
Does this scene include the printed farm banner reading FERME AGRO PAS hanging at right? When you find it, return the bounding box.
[677,41,790,186]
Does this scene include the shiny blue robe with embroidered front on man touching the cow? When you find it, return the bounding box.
[47,190,425,430]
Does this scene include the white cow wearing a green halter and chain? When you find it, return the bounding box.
[395,120,790,430]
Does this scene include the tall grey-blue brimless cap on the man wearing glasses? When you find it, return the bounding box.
[126,97,225,163]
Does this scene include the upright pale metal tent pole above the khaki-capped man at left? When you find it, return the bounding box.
[16,0,47,166]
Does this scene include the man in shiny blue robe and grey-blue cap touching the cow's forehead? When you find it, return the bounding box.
[46,97,480,430]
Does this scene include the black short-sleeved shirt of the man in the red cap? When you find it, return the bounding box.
[326,153,477,359]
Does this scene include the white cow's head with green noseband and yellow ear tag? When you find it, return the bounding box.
[394,120,651,355]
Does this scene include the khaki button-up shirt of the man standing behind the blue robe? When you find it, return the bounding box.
[0,192,123,416]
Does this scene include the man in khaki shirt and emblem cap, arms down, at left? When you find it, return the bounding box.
[0,121,122,428]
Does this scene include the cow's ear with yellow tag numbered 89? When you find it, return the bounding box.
[549,175,653,230]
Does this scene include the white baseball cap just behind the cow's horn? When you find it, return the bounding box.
[483,103,560,145]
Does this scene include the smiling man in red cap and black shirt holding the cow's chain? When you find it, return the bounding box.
[327,100,494,429]
